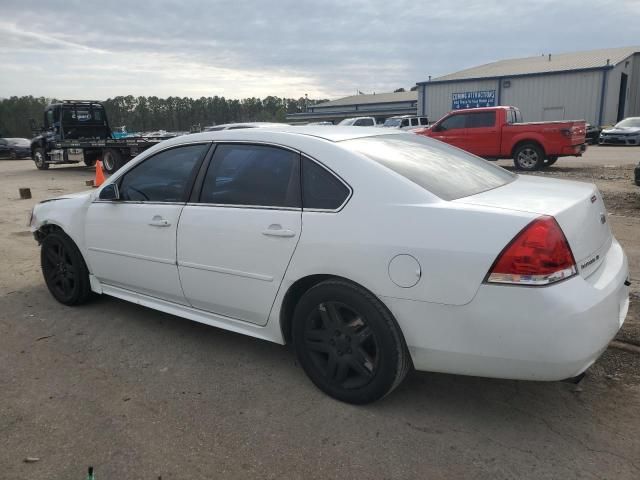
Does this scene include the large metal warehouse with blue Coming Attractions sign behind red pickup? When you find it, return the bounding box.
[418,47,640,125]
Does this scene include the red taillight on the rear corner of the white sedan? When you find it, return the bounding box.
[486,216,577,285]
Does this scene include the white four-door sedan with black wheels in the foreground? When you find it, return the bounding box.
[31,126,629,403]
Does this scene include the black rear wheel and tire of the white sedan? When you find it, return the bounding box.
[292,279,411,404]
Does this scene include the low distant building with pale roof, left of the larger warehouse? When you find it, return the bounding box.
[287,91,418,123]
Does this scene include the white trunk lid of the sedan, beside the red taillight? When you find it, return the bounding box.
[454,175,612,277]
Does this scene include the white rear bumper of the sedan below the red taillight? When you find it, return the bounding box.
[383,240,629,380]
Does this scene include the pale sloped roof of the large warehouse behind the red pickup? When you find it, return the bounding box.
[420,47,640,84]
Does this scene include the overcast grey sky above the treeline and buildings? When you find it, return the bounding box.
[0,0,640,100]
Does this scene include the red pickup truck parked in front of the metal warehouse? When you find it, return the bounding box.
[413,106,587,170]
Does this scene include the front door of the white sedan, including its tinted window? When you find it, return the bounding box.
[85,143,211,304]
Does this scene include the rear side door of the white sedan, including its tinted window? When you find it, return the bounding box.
[178,143,302,325]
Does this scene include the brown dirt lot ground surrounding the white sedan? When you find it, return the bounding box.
[0,147,640,480]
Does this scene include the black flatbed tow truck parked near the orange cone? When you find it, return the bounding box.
[31,100,175,173]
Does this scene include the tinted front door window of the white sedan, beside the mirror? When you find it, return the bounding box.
[119,144,209,202]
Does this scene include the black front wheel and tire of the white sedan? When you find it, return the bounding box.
[40,232,91,305]
